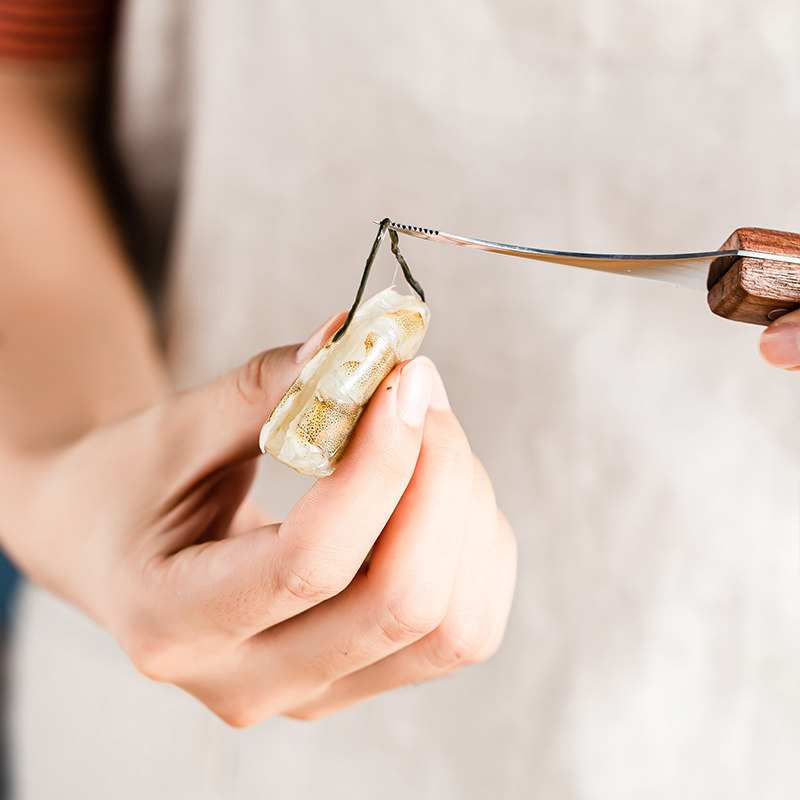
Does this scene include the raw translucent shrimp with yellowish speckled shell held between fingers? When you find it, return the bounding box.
[259,289,430,477]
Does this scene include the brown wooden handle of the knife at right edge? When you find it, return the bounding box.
[708,228,800,325]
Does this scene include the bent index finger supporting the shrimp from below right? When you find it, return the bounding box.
[161,358,432,637]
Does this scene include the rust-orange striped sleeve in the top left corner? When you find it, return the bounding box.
[0,0,117,61]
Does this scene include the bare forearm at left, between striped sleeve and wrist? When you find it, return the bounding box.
[0,67,167,454]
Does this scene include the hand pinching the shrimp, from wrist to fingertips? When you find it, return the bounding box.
[0,318,516,726]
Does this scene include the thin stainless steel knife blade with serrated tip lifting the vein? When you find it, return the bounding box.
[389,222,800,291]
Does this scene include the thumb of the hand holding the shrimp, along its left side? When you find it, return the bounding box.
[168,312,346,472]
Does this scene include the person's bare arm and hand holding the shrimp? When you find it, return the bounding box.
[0,64,516,726]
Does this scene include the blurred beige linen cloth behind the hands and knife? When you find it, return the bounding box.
[7,0,800,800]
